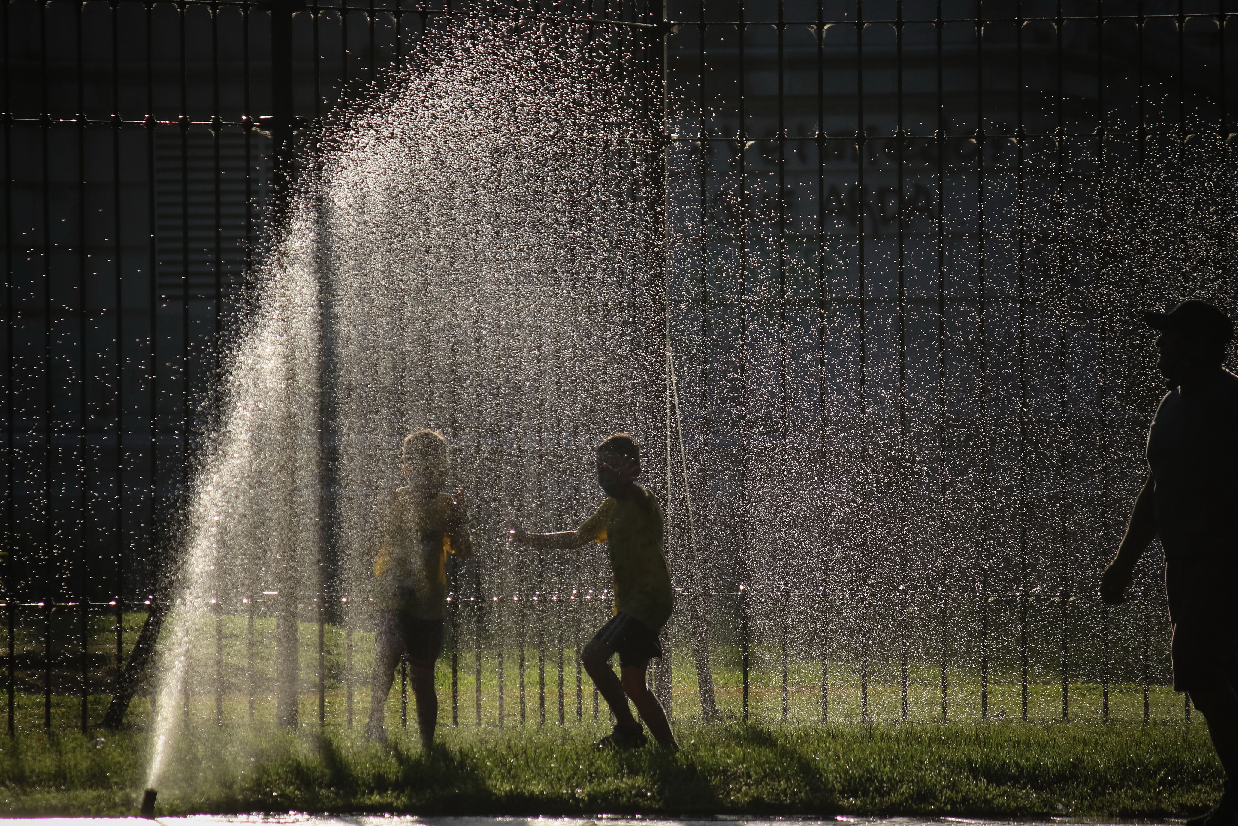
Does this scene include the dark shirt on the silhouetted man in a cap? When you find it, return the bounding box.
[1148,370,1238,630]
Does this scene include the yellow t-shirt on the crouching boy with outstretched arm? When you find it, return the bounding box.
[579,485,673,634]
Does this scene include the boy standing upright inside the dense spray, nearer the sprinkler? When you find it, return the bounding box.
[365,430,473,748]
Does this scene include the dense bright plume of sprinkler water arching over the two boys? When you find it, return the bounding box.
[147,21,665,786]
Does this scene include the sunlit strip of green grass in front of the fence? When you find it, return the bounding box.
[0,718,1221,819]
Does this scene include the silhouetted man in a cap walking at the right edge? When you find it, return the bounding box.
[1101,301,1238,826]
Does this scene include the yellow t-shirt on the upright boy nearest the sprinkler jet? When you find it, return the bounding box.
[374,488,468,619]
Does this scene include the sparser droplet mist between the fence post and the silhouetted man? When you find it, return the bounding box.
[671,127,1238,721]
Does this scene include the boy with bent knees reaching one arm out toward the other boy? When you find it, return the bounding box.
[511,433,678,750]
